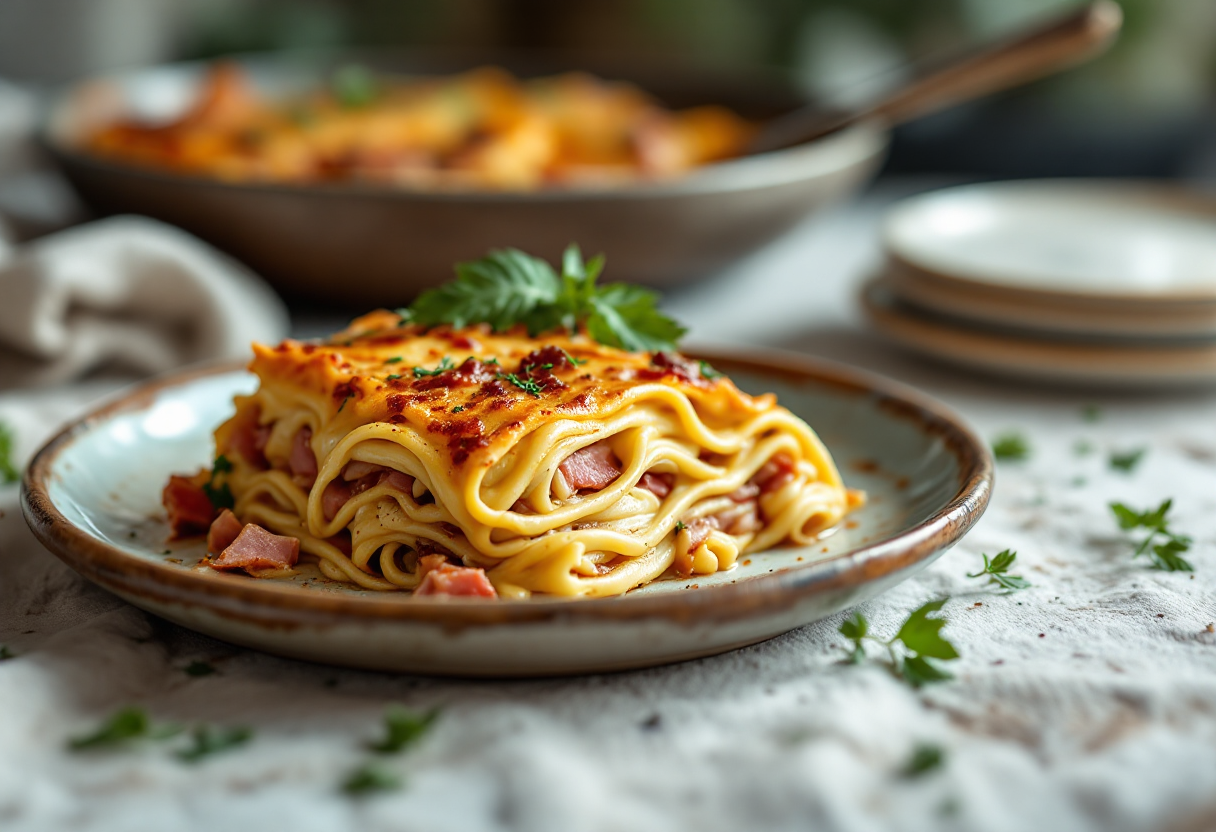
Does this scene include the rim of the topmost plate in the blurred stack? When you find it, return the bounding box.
[880,178,1216,307]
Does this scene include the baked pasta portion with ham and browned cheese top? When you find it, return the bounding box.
[167,311,851,597]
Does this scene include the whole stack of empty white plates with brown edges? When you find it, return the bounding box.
[862,180,1216,387]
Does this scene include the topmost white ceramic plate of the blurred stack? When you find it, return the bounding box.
[884,180,1216,304]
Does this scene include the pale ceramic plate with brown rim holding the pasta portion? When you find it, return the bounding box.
[23,352,992,676]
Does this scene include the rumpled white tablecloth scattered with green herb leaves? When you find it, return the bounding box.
[0,183,1216,832]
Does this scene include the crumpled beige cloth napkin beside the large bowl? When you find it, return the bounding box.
[0,217,288,389]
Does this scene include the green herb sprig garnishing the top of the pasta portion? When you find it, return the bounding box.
[398,244,685,352]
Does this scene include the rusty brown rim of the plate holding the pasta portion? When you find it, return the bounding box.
[21,348,995,631]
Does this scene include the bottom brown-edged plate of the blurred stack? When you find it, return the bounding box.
[862,279,1216,389]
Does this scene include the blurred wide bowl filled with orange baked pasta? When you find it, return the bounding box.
[43,54,886,305]
